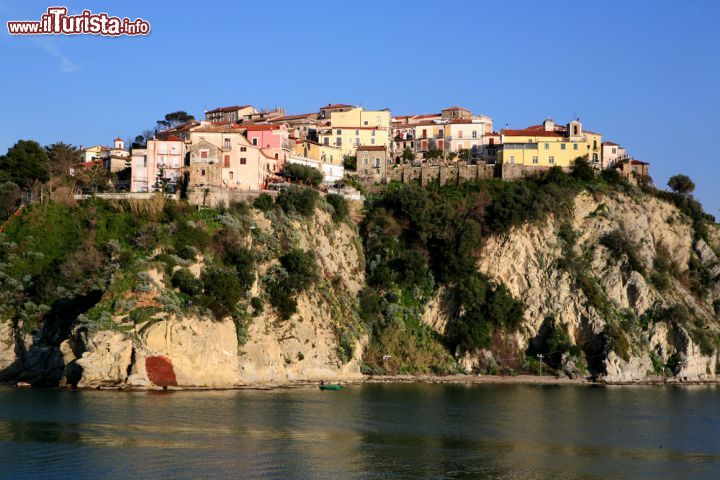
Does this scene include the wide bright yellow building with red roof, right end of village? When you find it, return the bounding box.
[497,119,602,168]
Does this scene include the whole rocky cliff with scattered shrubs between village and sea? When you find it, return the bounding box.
[0,178,720,388]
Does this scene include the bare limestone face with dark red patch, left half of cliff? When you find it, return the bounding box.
[0,210,366,388]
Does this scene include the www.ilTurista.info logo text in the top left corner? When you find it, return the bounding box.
[7,7,150,37]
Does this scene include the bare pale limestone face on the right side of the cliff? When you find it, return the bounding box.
[472,193,720,382]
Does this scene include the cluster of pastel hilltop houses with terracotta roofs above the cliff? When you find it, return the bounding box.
[83,104,648,197]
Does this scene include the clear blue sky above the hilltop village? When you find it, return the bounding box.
[0,0,720,214]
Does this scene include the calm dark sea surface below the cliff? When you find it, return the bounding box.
[0,385,720,479]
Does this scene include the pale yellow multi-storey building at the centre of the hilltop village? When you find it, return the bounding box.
[320,107,390,155]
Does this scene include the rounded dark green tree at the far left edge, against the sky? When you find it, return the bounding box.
[0,140,49,188]
